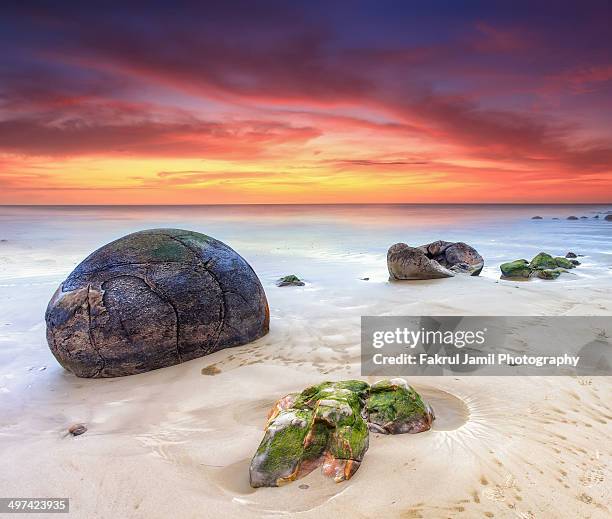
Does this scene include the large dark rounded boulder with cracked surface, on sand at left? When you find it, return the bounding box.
[45,229,269,378]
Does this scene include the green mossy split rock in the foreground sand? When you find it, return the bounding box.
[249,379,434,487]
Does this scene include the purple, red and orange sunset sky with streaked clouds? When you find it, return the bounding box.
[0,1,612,204]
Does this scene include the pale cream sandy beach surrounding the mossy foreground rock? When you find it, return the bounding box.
[0,264,612,518]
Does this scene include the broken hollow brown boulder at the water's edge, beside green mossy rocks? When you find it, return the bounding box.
[387,240,484,280]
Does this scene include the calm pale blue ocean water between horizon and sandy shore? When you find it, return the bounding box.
[0,205,612,288]
